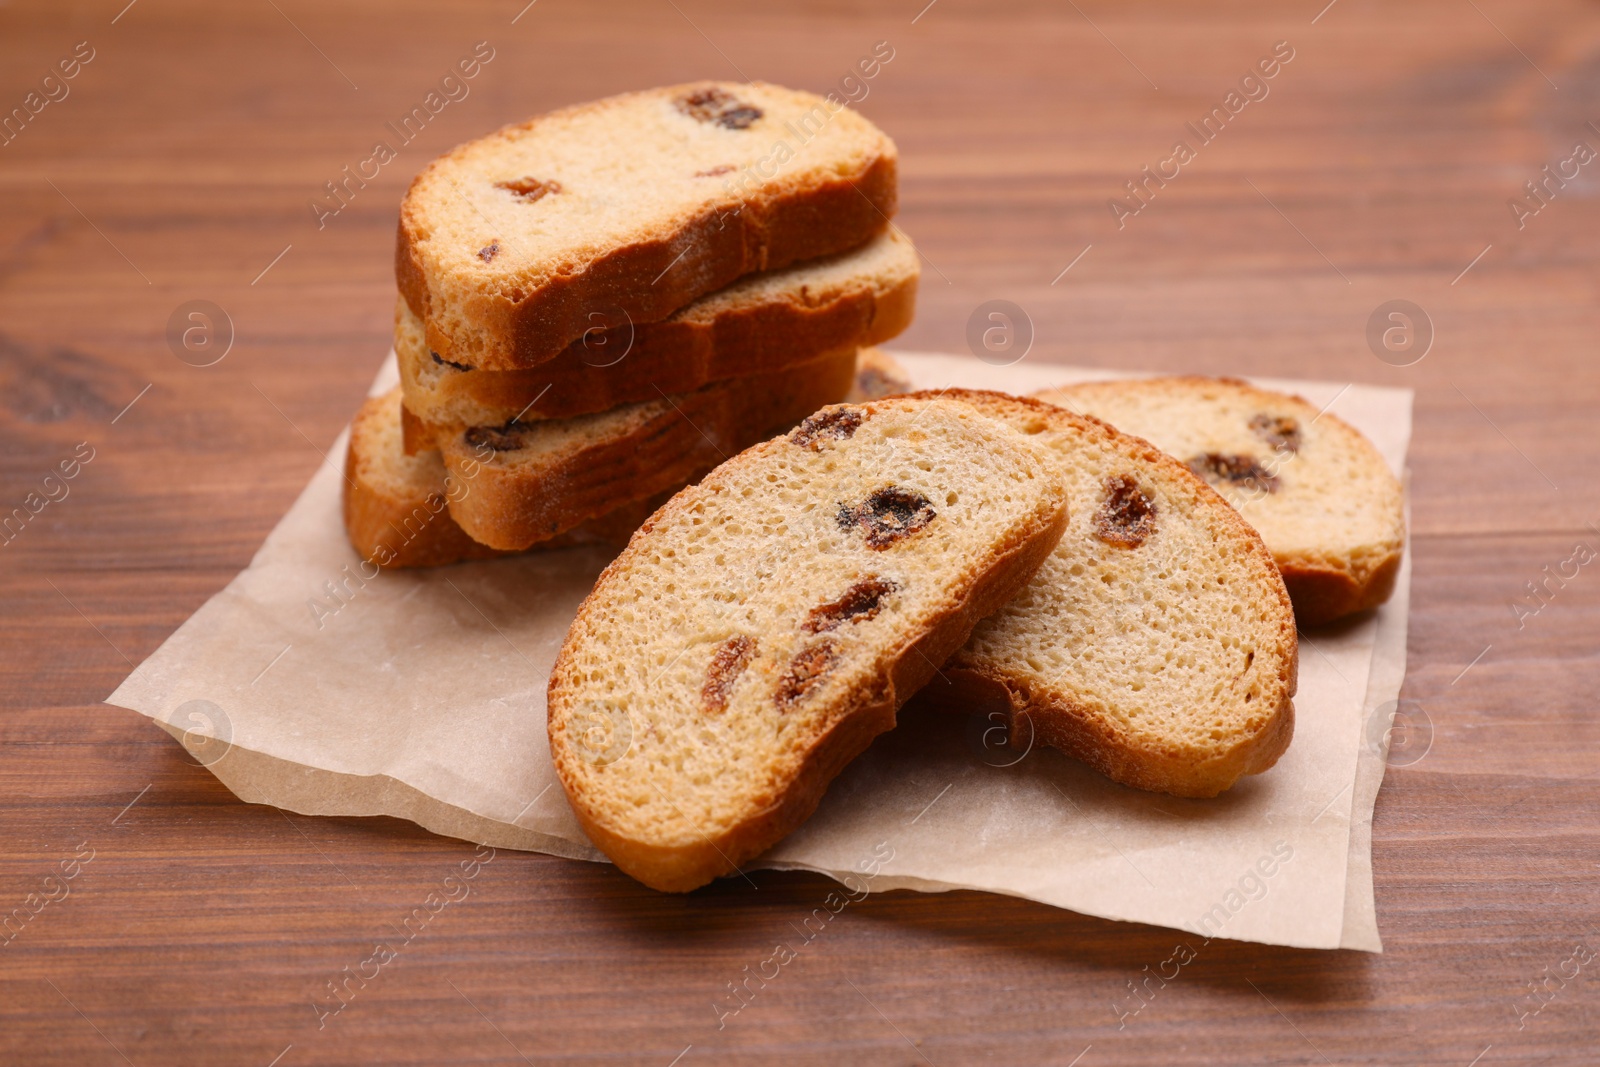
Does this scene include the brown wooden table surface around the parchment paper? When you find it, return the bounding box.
[0,0,1600,1067]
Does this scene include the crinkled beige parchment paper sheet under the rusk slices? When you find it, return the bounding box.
[107,354,1411,952]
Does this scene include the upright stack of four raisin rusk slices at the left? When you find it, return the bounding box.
[346,83,918,566]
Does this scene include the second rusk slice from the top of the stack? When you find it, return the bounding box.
[395,232,920,451]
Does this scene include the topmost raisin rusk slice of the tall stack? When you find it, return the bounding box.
[395,82,896,370]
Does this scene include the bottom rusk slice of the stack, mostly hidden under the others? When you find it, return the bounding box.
[344,389,661,568]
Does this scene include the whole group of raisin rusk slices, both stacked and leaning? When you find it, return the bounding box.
[346,83,1405,891]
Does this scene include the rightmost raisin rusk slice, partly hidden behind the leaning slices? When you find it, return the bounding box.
[1038,378,1405,625]
